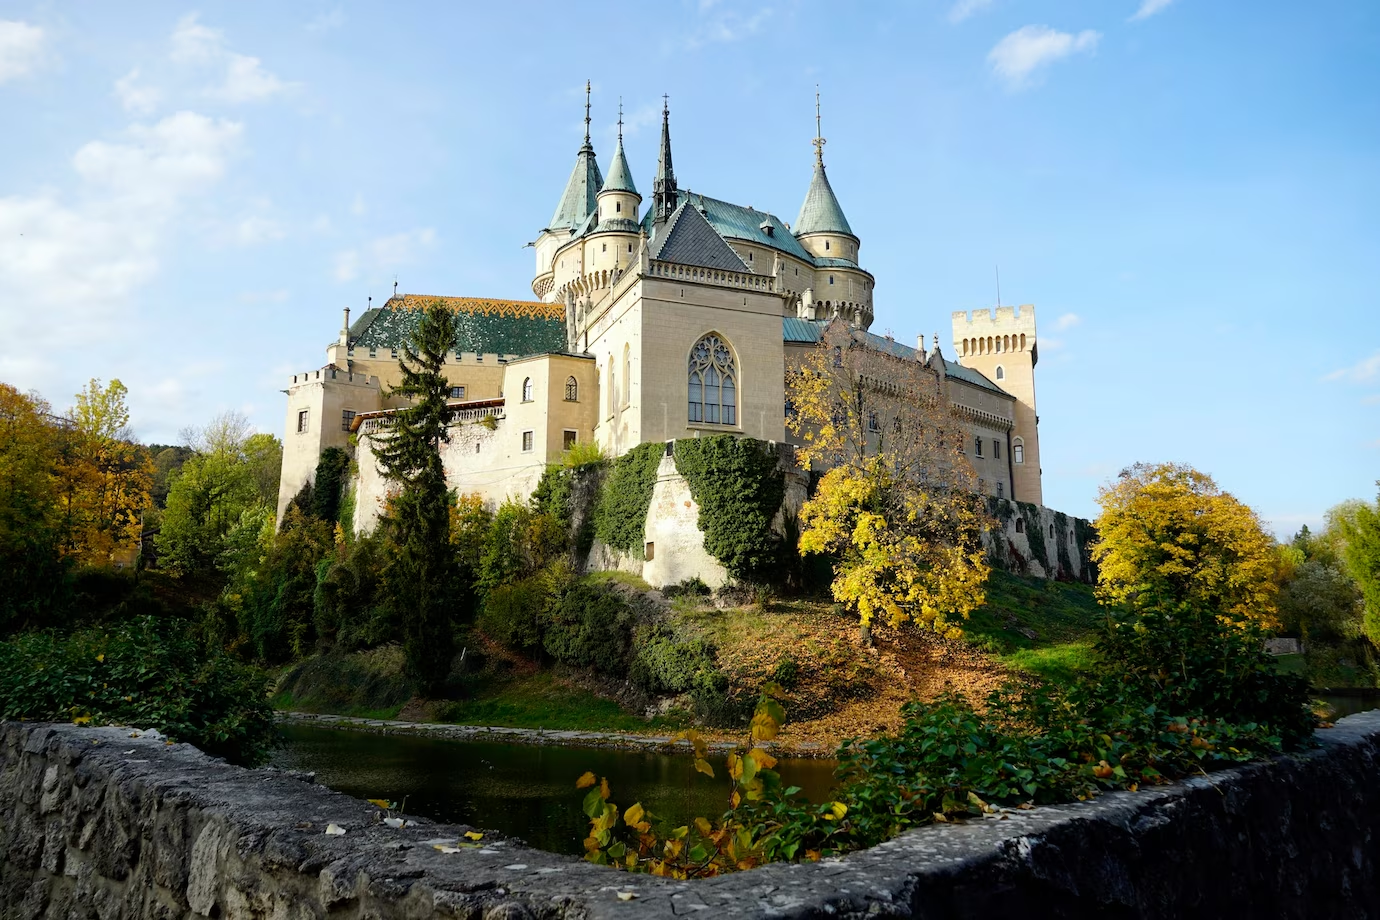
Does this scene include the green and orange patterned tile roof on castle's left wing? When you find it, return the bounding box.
[351,294,566,356]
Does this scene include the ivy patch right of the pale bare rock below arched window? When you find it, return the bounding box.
[676,434,785,581]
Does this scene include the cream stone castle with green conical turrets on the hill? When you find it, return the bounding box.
[279,93,1053,582]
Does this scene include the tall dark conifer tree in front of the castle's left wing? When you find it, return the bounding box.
[374,302,461,694]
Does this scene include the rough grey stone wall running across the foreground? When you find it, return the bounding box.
[0,712,1380,920]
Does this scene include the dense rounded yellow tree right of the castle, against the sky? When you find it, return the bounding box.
[1092,463,1279,626]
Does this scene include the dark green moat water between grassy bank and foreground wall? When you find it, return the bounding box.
[263,724,834,854]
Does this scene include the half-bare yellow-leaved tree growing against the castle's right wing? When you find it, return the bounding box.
[787,321,991,634]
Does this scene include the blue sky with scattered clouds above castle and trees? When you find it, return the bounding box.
[0,0,1380,532]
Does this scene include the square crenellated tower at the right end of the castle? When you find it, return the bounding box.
[954,303,1045,505]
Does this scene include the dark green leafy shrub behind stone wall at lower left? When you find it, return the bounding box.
[0,617,277,764]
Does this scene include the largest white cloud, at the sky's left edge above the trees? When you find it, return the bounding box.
[0,112,242,353]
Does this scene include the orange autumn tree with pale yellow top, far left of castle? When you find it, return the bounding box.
[58,379,153,566]
